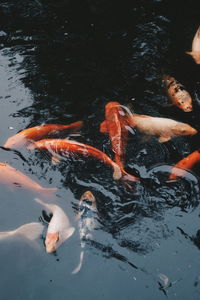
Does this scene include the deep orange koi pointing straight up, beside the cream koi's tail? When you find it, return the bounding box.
[100,102,138,181]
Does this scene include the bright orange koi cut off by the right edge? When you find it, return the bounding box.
[169,149,200,180]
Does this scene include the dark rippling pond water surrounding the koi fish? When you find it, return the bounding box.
[0,0,200,300]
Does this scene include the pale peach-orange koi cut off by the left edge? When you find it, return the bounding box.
[0,163,57,197]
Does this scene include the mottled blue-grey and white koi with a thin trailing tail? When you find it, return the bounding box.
[72,191,97,274]
